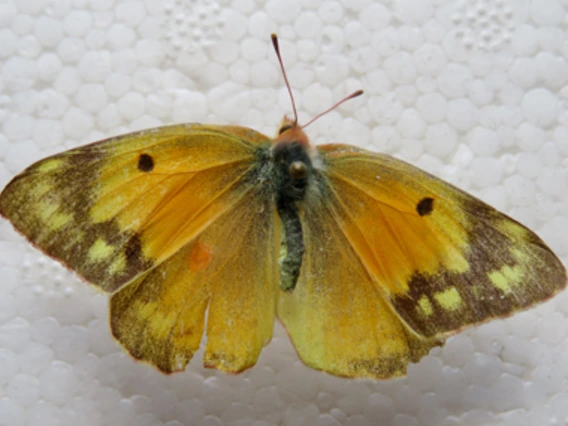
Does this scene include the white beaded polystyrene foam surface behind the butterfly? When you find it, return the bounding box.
[0,0,568,426]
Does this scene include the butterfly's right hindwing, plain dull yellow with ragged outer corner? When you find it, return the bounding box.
[278,190,440,378]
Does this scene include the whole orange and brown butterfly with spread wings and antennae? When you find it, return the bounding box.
[0,35,567,379]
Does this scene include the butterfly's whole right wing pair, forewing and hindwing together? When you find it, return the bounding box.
[278,145,566,378]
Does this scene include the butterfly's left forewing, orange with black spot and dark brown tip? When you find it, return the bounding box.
[0,125,270,292]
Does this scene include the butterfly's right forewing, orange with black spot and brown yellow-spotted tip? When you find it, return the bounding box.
[320,145,566,338]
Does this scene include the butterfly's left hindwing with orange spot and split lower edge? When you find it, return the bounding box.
[110,191,278,373]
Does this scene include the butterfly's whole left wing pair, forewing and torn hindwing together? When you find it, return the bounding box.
[0,125,279,372]
